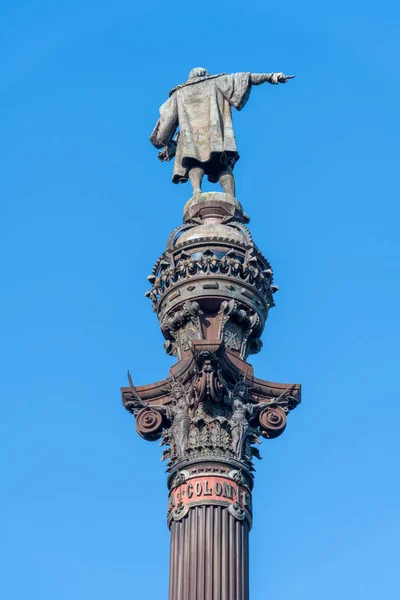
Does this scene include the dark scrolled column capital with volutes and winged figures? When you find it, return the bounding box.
[123,340,300,472]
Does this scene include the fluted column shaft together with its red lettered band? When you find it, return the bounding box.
[168,462,252,600]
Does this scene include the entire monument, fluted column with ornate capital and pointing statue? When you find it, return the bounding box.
[121,69,301,600]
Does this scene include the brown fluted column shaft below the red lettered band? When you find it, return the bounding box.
[169,506,249,600]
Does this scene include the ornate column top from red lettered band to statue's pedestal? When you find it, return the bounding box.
[122,193,301,531]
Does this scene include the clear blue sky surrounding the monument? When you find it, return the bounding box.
[0,0,400,600]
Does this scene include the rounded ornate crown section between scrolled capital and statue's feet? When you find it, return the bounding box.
[146,206,278,361]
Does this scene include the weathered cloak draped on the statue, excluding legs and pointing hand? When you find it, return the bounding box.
[150,73,251,183]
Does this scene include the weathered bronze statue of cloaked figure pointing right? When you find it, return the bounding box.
[150,67,294,196]
